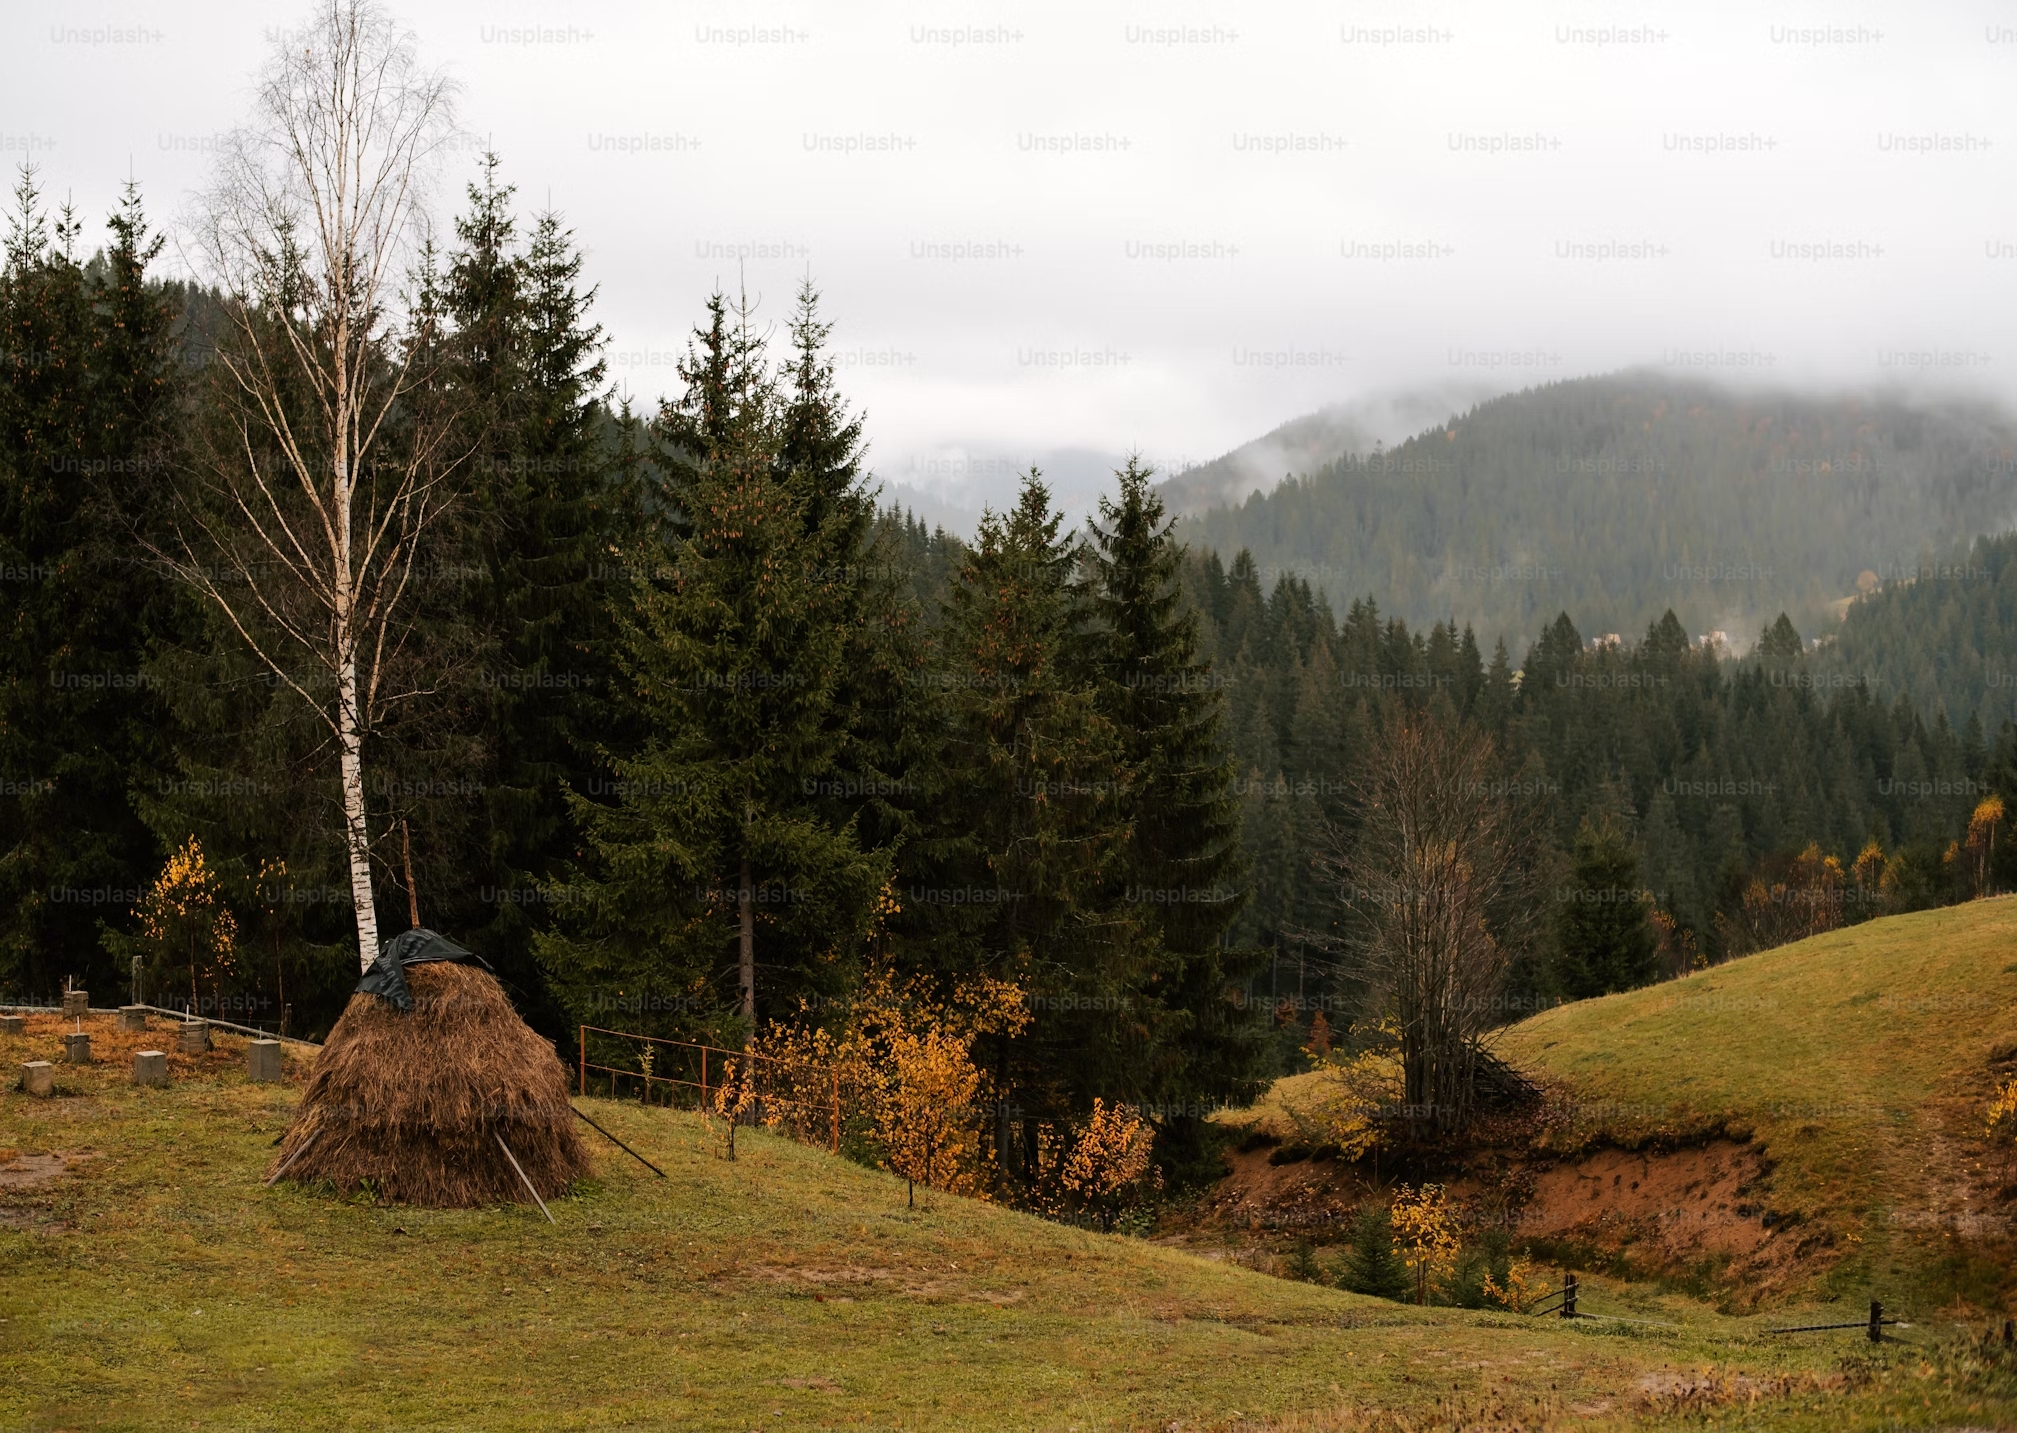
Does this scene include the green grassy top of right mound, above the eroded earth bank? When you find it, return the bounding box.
[1501,898,2017,1308]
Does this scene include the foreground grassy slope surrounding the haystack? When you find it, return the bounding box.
[0,1017,2017,1433]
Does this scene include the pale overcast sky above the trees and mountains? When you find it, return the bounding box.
[0,0,2017,520]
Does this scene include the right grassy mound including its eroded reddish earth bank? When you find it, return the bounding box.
[1184,898,2017,1318]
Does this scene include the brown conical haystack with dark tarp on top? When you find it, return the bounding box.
[268,930,589,1209]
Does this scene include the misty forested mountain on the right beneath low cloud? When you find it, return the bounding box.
[1184,373,2017,652]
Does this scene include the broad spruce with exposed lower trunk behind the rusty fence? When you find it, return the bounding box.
[539,295,887,1037]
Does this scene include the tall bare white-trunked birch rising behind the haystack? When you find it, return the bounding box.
[161,0,456,965]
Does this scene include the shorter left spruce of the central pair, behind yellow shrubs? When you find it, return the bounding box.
[935,470,1129,1177]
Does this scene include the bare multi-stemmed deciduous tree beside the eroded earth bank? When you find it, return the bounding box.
[1325,710,1539,1130]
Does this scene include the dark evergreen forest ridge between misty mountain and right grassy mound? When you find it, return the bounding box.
[1186,551,2017,1057]
